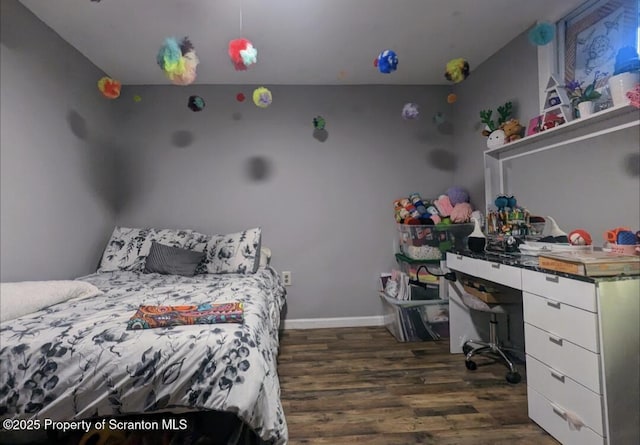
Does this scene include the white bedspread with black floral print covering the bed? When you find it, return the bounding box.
[0,268,287,444]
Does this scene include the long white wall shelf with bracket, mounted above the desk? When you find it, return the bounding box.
[484,105,640,211]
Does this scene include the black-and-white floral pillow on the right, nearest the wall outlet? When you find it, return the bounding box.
[203,227,262,274]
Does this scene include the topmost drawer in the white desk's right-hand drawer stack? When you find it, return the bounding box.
[522,269,598,312]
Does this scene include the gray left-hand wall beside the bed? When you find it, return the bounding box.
[0,0,117,281]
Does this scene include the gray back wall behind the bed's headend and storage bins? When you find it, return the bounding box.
[112,86,455,319]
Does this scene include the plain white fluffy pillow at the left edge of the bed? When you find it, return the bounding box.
[0,280,102,321]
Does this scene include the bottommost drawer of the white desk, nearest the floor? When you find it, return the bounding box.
[527,387,605,445]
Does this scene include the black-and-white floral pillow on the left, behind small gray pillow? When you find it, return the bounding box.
[98,227,193,272]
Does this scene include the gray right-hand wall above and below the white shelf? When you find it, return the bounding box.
[453,33,640,246]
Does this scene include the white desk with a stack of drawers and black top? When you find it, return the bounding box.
[447,253,640,445]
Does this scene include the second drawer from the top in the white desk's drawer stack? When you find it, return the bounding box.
[522,292,600,353]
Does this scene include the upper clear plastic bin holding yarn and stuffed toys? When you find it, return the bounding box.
[397,224,474,260]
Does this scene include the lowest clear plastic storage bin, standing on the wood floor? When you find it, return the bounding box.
[380,292,449,342]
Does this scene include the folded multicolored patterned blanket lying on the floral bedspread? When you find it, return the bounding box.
[127,302,244,329]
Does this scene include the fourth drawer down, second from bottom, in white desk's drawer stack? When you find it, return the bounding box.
[527,355,604,436]
